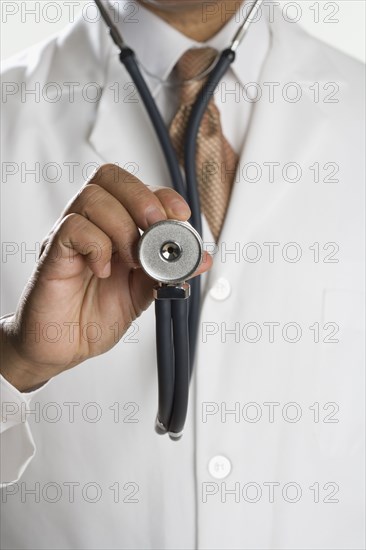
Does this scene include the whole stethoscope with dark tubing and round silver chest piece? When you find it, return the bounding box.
[94,0,263,440]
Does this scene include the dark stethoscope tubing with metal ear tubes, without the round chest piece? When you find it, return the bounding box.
[95,0,262,439]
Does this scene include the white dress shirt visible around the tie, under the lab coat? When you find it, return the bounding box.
[112,0,270,153]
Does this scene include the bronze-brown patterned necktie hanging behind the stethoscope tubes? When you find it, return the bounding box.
[170,48,238,242]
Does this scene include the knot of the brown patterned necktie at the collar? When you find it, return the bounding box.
[175,47,217,105]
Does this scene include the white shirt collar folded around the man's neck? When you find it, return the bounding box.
[110,0,271,93]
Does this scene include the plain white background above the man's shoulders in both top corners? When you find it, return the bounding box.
[0,0,366,61]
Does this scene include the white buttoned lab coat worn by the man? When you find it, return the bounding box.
[2,5,365,550]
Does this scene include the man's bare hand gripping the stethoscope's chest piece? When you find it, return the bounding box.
[2,164,212,391]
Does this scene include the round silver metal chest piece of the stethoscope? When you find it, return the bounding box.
[138,220,203,285]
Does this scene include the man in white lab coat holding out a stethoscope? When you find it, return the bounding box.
[2,1,364,549]
